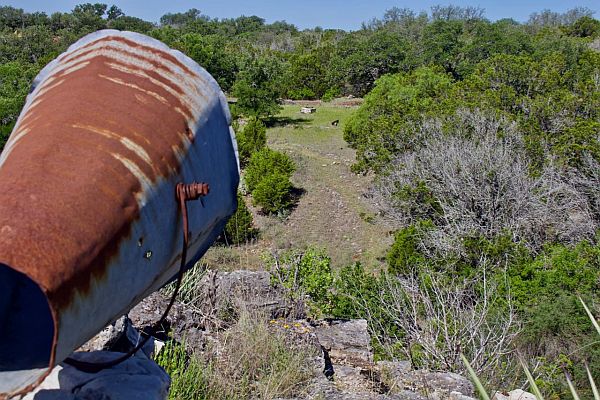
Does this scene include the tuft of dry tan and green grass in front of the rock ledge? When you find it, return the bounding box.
[157,306,316,400]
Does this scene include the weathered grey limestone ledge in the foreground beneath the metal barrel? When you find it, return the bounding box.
[50,271,482,400]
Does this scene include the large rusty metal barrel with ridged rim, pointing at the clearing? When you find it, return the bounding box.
[0,30,239,398]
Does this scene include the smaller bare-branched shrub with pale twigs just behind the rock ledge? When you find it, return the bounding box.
[333,259,519,376]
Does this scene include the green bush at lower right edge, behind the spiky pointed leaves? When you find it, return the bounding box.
[508,241,600,394]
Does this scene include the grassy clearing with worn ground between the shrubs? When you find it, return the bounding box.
[204,103,392,270]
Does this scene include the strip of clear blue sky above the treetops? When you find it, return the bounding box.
[0,0,600,30]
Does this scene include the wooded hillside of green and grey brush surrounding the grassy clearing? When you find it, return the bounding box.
[0,3,600,398]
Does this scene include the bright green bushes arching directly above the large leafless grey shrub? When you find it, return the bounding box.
[344,48,600,171]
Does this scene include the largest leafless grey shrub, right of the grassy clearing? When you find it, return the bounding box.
[377,110,598,254]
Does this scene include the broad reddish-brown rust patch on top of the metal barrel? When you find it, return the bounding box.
[0,43,197,310]
